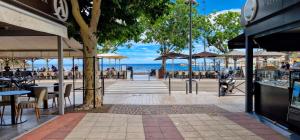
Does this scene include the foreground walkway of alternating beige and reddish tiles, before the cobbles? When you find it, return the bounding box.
[19,113,285,140]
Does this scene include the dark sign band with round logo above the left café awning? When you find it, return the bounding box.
[2,0,69,22]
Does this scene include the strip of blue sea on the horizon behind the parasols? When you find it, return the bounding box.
[34,64,219,73]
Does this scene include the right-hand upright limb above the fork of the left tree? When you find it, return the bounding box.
[90,0,102,32]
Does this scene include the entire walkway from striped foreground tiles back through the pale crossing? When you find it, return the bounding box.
[13,80,286,140]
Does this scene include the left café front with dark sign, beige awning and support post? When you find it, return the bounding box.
[0,0,69,115]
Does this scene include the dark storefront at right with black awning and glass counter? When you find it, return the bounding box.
[228,0,300,133]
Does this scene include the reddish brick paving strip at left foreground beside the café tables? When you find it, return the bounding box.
[18,113,85,140]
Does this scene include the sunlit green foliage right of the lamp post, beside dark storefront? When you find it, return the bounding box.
[198,11,242,53]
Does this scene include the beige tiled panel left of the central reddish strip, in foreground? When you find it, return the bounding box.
[66,113,145,140]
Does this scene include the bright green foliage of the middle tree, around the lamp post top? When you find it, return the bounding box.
[144,0,200,54]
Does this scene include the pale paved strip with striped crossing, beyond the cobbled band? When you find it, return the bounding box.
[104,80,245,112]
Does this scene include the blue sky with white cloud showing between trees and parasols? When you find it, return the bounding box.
[36,0,245,64]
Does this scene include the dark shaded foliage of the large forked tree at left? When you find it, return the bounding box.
[68,0,170,52]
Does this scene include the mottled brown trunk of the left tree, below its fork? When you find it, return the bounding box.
[81,31,102,108]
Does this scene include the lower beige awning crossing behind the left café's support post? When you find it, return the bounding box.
[0,36,83,58]
